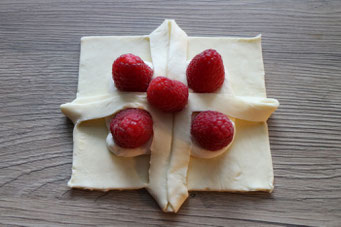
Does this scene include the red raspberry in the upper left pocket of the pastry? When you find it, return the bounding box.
[112,54,153,92]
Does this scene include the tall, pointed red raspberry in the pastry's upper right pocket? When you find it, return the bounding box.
[186,49,225,93]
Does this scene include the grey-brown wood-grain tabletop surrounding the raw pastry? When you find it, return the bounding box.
[0,0,341,226]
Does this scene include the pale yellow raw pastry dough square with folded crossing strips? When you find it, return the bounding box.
[61,20,279,212]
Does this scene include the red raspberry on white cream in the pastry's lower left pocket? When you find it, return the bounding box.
[110,109,153,148]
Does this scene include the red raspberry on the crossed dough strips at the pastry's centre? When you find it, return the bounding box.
[147,76,188,112]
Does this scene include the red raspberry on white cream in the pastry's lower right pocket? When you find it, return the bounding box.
[191,111,234,151]
